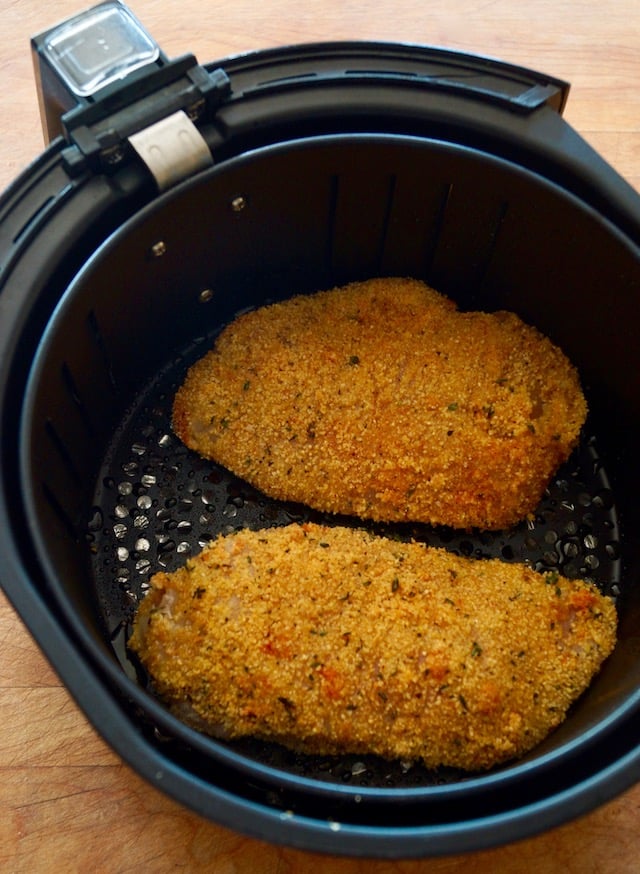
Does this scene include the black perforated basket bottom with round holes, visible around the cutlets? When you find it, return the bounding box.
[87,340,620,788]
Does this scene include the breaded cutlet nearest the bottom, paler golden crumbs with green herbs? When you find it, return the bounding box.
[130,523,616,770]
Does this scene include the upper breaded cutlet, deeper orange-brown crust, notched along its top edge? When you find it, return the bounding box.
[173,279,586,529]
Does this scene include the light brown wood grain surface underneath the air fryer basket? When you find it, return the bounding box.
[0,0,640,874]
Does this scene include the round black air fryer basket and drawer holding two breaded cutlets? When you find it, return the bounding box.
[0,11,640,857]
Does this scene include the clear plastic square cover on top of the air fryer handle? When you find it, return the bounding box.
[44,2,160,97]
